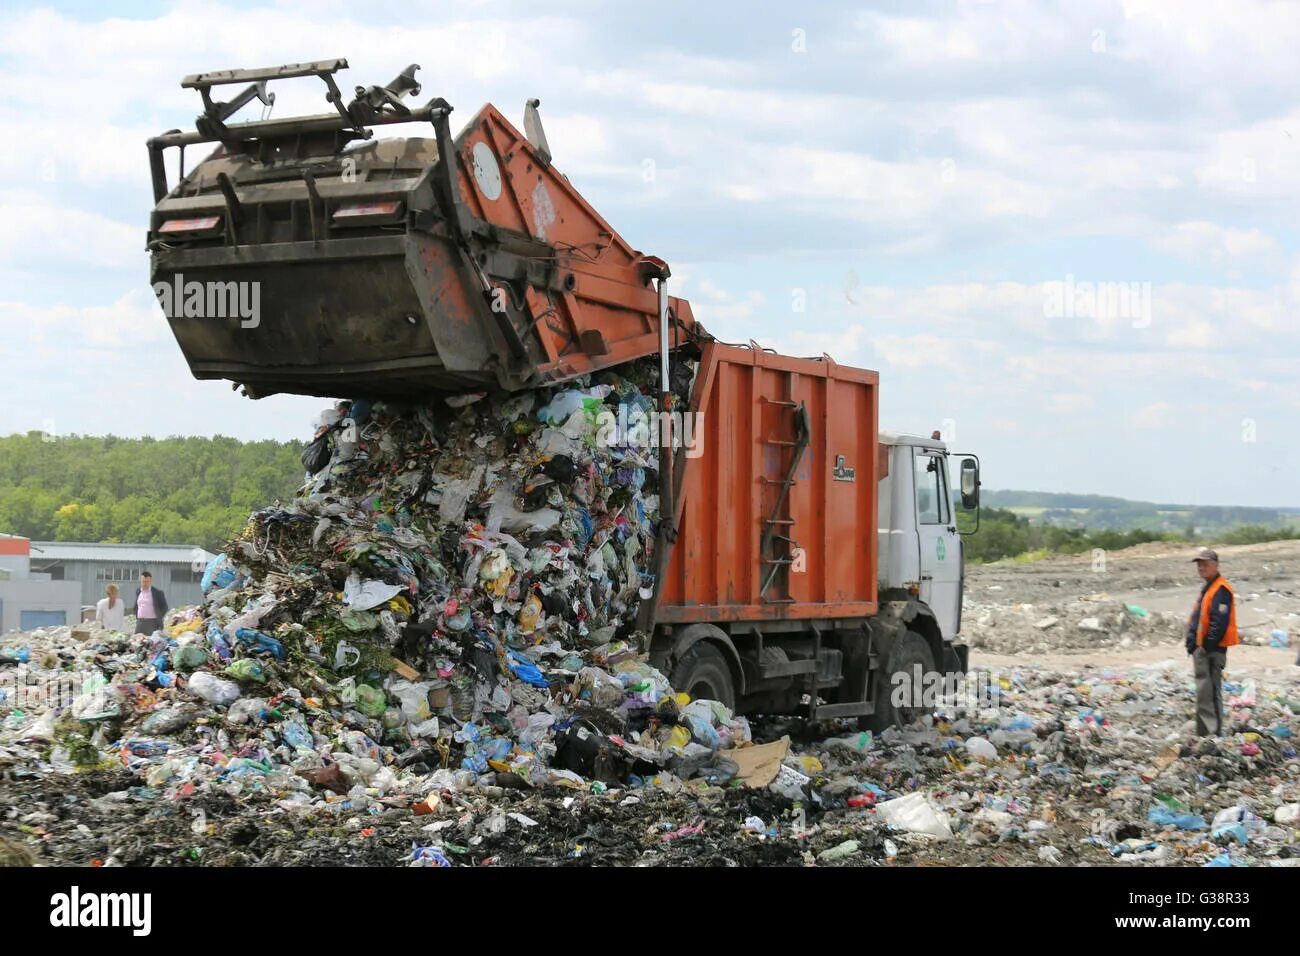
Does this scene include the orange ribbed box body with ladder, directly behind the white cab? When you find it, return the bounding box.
[655,342,879,624]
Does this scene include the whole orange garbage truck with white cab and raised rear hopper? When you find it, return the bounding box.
[147,60,980,728]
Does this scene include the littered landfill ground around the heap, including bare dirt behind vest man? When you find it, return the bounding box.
[0,541,1300,866]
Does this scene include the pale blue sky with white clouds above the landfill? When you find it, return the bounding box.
[0,0,1300,507]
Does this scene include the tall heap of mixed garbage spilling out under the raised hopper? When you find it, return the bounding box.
[5,362,774,804]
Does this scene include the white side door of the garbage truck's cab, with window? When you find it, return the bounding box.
[913,447,962,637]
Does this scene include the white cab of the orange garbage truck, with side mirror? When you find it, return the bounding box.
[878,432,979,641]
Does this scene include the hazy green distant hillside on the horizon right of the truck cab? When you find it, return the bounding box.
[982,490,1300,537]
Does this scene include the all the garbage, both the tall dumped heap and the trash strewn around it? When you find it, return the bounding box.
[0,363,1300,866]
